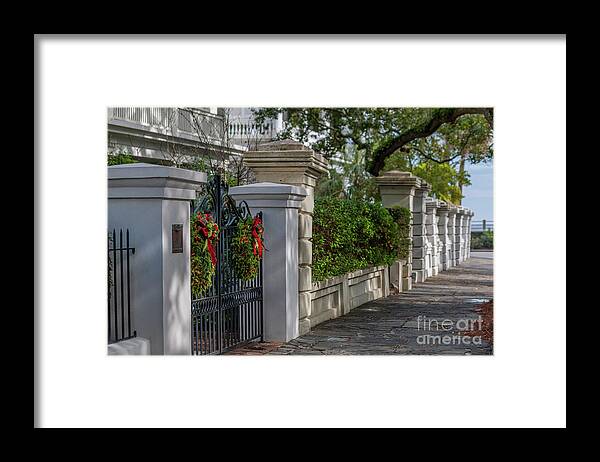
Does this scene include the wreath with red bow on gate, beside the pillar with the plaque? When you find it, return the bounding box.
[190,212,219,297]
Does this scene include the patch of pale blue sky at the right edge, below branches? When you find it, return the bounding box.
[462,162,494,221]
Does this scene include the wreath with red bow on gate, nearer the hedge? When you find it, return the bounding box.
[232,215,264,281]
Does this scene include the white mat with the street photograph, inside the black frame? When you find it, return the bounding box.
[33,33,567,434]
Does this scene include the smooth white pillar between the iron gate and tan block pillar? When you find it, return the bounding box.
[229,182,307,342]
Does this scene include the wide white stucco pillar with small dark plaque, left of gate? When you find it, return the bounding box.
[108,163,206,355]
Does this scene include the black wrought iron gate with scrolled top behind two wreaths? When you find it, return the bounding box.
[192,175,263,355]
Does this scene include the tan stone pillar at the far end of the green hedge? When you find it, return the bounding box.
[375,170,421,291]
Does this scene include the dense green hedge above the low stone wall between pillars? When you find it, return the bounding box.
[312,197,410,282]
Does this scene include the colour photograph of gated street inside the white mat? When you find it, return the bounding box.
[107,107,494,355]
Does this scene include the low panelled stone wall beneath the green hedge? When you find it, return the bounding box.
[308,265,390,327]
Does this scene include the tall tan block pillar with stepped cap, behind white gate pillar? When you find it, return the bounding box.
[244,140,328,335]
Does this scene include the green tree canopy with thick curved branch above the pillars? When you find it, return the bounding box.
[255,108,493,203]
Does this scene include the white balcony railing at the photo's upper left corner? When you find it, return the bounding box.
[108,107,224,141]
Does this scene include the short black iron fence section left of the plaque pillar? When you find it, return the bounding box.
[108,229,136,343]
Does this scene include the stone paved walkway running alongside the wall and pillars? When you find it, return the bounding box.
[266,252,493,355]
